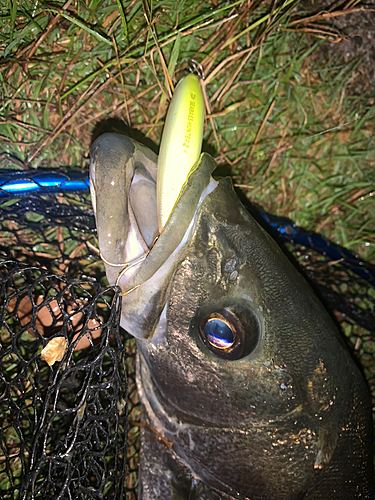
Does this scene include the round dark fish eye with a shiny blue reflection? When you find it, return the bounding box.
[198,308,260,360]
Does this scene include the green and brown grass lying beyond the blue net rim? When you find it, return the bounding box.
[0,0,375,494]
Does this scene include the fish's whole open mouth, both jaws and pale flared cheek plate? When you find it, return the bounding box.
[90,134,218,339]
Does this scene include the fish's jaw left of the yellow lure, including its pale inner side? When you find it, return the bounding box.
[90,133,158,284]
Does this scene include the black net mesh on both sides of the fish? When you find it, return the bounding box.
[0,178,375,499]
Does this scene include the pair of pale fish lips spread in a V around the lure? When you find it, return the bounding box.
[90,134,216,293]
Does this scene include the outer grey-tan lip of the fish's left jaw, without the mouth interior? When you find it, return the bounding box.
[90,133,157,285]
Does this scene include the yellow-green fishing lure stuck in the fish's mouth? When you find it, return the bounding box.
[156,74,204,232]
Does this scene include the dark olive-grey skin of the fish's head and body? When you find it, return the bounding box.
[92,135,374,500]
